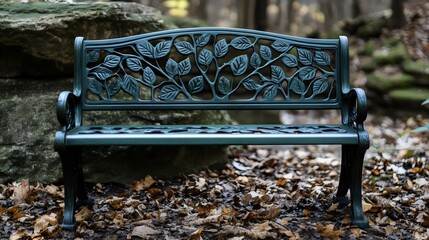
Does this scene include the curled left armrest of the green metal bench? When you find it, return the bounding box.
[57,91,78,131]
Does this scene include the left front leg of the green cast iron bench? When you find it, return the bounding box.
[60,150,76,231]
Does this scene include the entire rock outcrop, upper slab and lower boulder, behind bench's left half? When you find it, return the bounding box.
[0,3,229,183]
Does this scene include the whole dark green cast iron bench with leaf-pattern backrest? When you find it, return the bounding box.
[55,28,369,230]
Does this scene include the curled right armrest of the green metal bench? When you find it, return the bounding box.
[342,88,367,130]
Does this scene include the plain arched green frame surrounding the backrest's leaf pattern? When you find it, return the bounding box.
[74,28,350,111]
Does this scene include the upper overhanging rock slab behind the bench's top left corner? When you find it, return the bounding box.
[0,2,167,77]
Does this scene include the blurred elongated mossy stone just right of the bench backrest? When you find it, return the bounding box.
[367,71,415,92]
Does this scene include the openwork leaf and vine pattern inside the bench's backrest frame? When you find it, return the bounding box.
[86,32,337,101]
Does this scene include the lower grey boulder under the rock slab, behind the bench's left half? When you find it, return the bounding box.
[0,79,230,183]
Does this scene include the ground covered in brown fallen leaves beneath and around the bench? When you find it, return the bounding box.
[0,115,429,240]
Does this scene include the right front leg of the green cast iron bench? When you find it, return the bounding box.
[350,146,369,228]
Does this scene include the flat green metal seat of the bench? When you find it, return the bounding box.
[66,124,358,146]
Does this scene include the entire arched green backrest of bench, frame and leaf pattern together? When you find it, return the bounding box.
[74,28,349,110]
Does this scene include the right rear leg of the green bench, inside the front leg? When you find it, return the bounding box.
[334,145,355,206]
